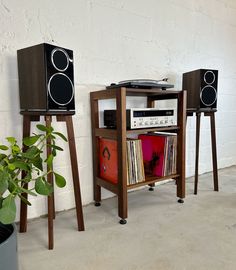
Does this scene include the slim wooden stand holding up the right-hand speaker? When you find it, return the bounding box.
[186,110,219,194]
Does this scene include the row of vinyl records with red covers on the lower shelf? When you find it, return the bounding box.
[99,132,177,185]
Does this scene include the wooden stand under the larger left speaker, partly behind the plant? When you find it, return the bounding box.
[20,112,84,249]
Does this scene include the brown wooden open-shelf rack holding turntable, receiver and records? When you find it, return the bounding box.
[90,87,186,224]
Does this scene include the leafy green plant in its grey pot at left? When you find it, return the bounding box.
[0,124,67,270]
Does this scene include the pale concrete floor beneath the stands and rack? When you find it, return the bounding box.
[18,167,236,270]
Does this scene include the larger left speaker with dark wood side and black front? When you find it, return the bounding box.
[17,43,75,114]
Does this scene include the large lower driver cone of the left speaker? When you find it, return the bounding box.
[48,73,74,106]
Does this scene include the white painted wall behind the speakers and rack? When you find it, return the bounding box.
[0,0,236,217]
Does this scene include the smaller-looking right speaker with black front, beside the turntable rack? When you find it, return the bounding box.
[183,69,218,111]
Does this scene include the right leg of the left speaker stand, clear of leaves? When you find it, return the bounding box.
[65,116,84,231]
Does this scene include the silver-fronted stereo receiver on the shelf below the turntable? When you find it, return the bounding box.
[104,108,177,129]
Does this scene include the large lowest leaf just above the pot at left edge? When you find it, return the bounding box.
[0,194,16,224]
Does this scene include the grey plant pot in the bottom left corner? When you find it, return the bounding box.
[0,223,18,270]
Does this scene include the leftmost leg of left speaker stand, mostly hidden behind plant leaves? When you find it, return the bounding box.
[20,115,30,232]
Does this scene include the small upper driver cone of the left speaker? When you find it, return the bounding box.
[51,48,69,71]
